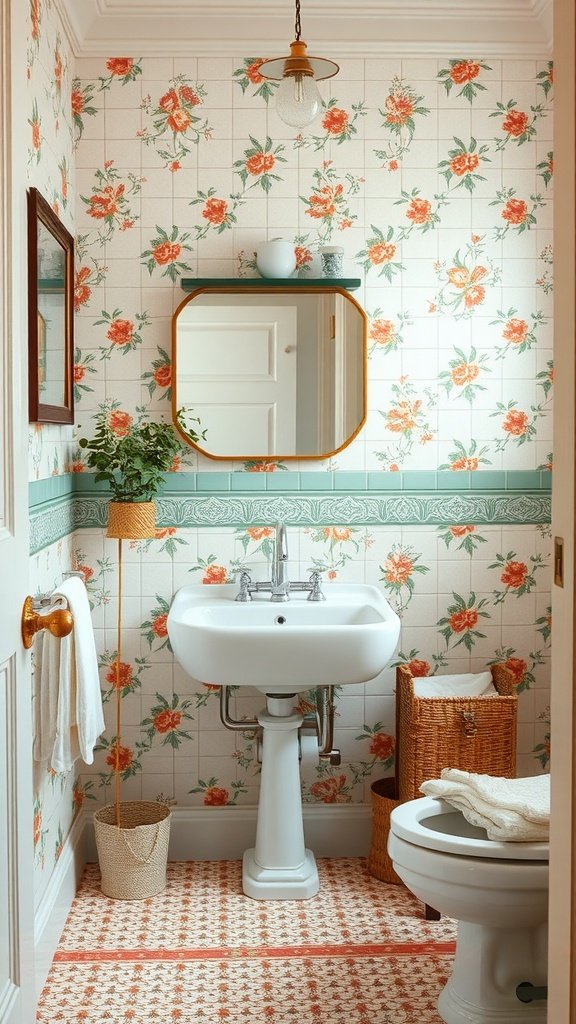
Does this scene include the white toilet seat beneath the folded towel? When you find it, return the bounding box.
[390,797,548,861]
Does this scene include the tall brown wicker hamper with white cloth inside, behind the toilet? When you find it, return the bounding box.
[396,665,518,801]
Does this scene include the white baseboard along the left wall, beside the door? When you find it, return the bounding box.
[34,814,86,996]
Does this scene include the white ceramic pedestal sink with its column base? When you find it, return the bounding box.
[168,584,400,899]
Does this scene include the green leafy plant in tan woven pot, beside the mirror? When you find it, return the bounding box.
[78,413,181,540]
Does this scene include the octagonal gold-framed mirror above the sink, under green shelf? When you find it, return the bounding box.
[172,282,368,461]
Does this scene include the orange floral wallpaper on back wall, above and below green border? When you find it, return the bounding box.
[28,24,553,892]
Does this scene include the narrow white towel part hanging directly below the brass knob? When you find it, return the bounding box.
[32,630,60,761]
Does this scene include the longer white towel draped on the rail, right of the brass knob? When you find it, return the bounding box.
[51,577,106,772]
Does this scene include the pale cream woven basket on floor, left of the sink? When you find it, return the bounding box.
[94,800,170,899]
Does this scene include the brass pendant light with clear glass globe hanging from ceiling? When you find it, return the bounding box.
[258,0,339,128]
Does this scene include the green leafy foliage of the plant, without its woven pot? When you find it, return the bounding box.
[78,413,181,503]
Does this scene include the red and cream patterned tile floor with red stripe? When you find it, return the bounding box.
[37,858,455,1024]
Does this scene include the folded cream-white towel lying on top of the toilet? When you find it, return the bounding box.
[420,768,550,843]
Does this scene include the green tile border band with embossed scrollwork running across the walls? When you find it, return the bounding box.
[30,471,551,553]
